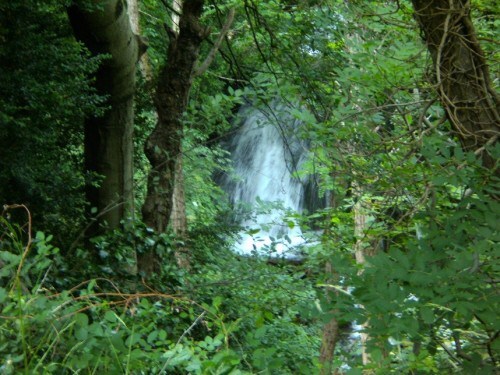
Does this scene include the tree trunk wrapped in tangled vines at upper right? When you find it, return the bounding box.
[412,0,500,176]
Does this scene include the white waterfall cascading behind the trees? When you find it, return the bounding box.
[222,103,307,258]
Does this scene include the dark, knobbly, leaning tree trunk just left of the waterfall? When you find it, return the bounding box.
[139,0,208,274]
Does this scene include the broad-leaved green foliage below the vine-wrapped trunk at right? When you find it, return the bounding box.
[316,158,499,374]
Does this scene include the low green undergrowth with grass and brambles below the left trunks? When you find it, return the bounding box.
[0,206,319,375]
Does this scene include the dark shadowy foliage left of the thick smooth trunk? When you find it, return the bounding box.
[0,0,102,244]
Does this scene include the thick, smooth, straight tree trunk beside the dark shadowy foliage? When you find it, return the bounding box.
[68,0,145,236]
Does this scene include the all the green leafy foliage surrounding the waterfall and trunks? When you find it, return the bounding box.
[0,0,500,374]
